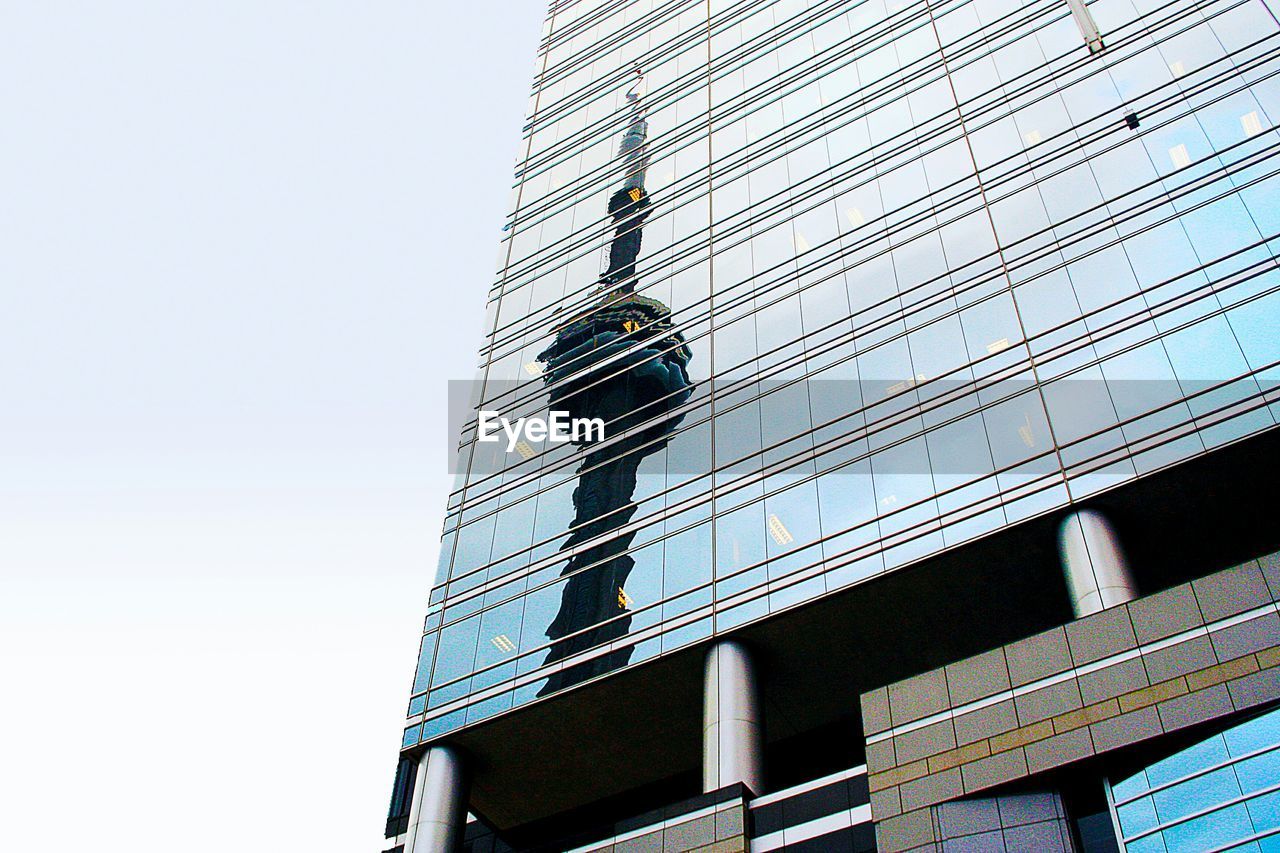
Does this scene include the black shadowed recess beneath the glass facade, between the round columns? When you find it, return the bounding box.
[437,429,1280,830]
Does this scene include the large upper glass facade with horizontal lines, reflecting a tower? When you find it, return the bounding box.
[403,0,1280,748]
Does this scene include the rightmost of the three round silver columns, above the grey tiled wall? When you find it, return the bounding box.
[1057,510,1138,619]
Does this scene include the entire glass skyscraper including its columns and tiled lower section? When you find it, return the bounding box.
[387,0,1280,853]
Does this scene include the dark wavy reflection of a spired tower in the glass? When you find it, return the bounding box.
[538,70,692,695]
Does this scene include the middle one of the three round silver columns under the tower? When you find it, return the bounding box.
[703,640,764,794]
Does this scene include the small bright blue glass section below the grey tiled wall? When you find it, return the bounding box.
[1111,710,1280,853]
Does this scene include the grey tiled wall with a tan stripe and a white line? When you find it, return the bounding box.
[861,555,1280,852]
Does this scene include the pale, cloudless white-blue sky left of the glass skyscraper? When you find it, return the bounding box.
[0,0,544,853]
